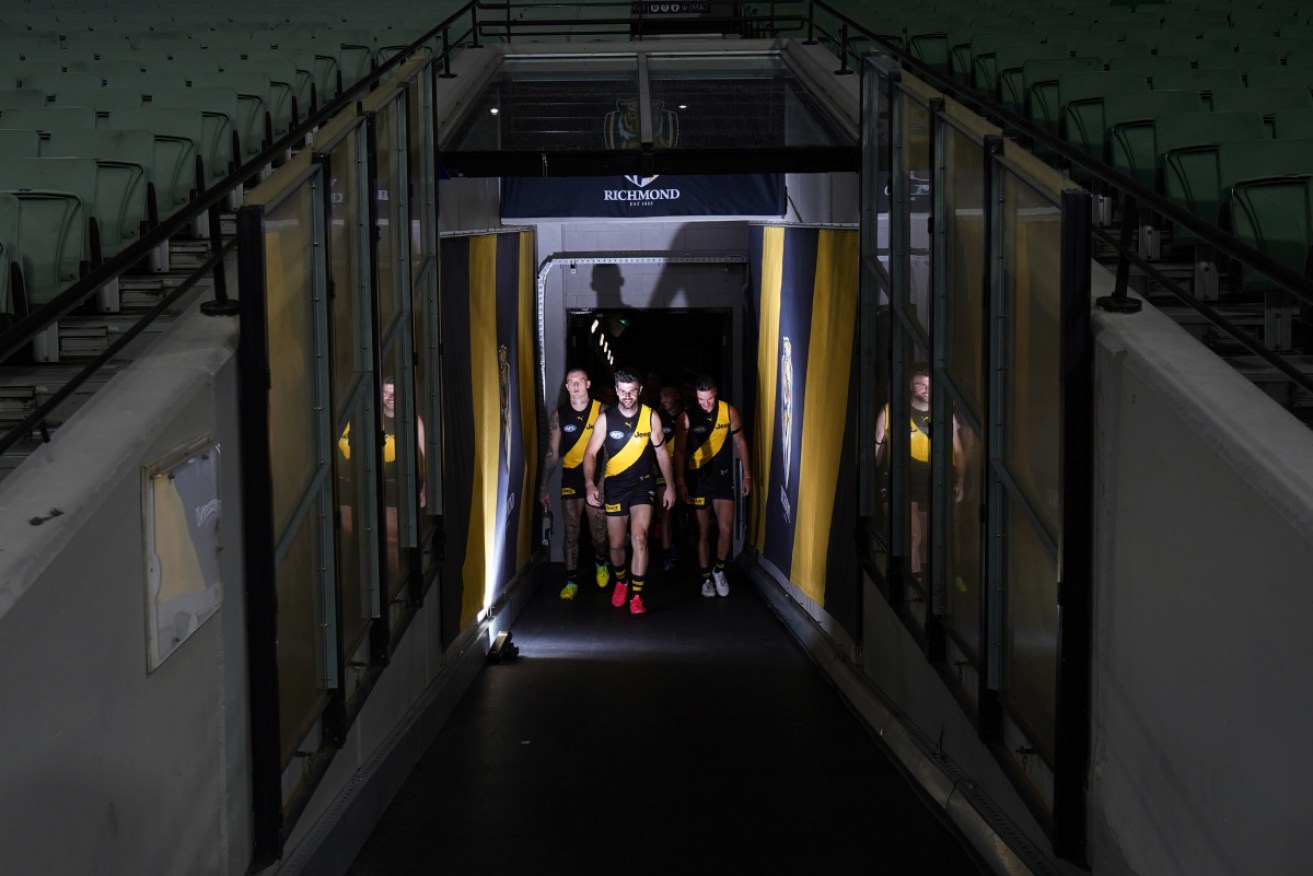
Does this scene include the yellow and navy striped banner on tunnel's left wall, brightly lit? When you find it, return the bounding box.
[440,231,538,644]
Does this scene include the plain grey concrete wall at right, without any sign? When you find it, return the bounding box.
[1090,286,1313,876]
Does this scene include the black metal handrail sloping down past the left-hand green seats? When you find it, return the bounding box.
[0,0,479,453]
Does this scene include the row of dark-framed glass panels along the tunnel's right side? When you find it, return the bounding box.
[861,56,1091,847]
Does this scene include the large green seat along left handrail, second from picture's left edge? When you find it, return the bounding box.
[0,158,96,307]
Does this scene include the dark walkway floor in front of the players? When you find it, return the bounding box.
[348,571,982,876]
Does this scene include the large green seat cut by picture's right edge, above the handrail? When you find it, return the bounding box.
[1217,141,1313,290]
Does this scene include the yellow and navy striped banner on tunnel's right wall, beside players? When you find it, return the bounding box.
[748,226,859,632]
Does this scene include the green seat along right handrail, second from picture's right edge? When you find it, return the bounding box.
[1153,112,1266,244]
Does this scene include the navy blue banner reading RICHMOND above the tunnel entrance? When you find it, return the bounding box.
[502,173,785,219]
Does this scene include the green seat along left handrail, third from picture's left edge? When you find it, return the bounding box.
[43,129,156,257]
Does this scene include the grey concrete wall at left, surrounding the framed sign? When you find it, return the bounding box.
[0,299,251,876]
